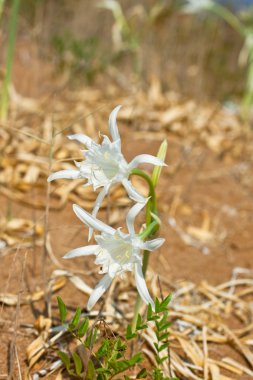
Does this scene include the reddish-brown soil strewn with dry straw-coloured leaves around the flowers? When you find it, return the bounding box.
[0,40,253,380]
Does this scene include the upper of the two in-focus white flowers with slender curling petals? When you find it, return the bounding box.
[48,106,165,238]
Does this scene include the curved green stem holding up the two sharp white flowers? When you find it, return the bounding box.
[131,169,159,331]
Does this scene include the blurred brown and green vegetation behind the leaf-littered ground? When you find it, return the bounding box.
[0,0,253,103]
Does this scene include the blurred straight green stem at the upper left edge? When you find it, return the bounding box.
[0,0,20,122]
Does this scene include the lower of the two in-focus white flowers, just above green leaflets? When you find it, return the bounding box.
[64,203,164,310]
